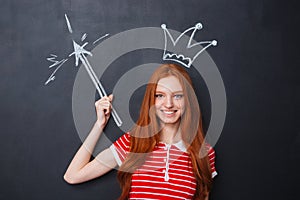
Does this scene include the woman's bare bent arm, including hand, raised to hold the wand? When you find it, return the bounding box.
[64,95,117,184]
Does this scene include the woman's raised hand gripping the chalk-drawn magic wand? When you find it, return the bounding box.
[95,94,113,128]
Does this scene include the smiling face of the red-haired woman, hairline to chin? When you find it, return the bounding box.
[155,76,185,124]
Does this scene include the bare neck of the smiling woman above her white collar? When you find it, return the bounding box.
[160,123,181,144]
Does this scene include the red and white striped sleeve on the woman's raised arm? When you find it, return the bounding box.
[109,133,130,166]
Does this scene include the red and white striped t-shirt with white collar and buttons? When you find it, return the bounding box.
[110,133,217,200]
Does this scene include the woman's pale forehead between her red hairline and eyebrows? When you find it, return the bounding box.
[156,76,182,92]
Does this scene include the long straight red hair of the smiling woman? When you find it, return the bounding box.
[118,64,212,200]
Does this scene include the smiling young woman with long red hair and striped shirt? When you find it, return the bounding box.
[64,64,217,200]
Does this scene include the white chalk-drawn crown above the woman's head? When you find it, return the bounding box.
[161,23,217,68]
